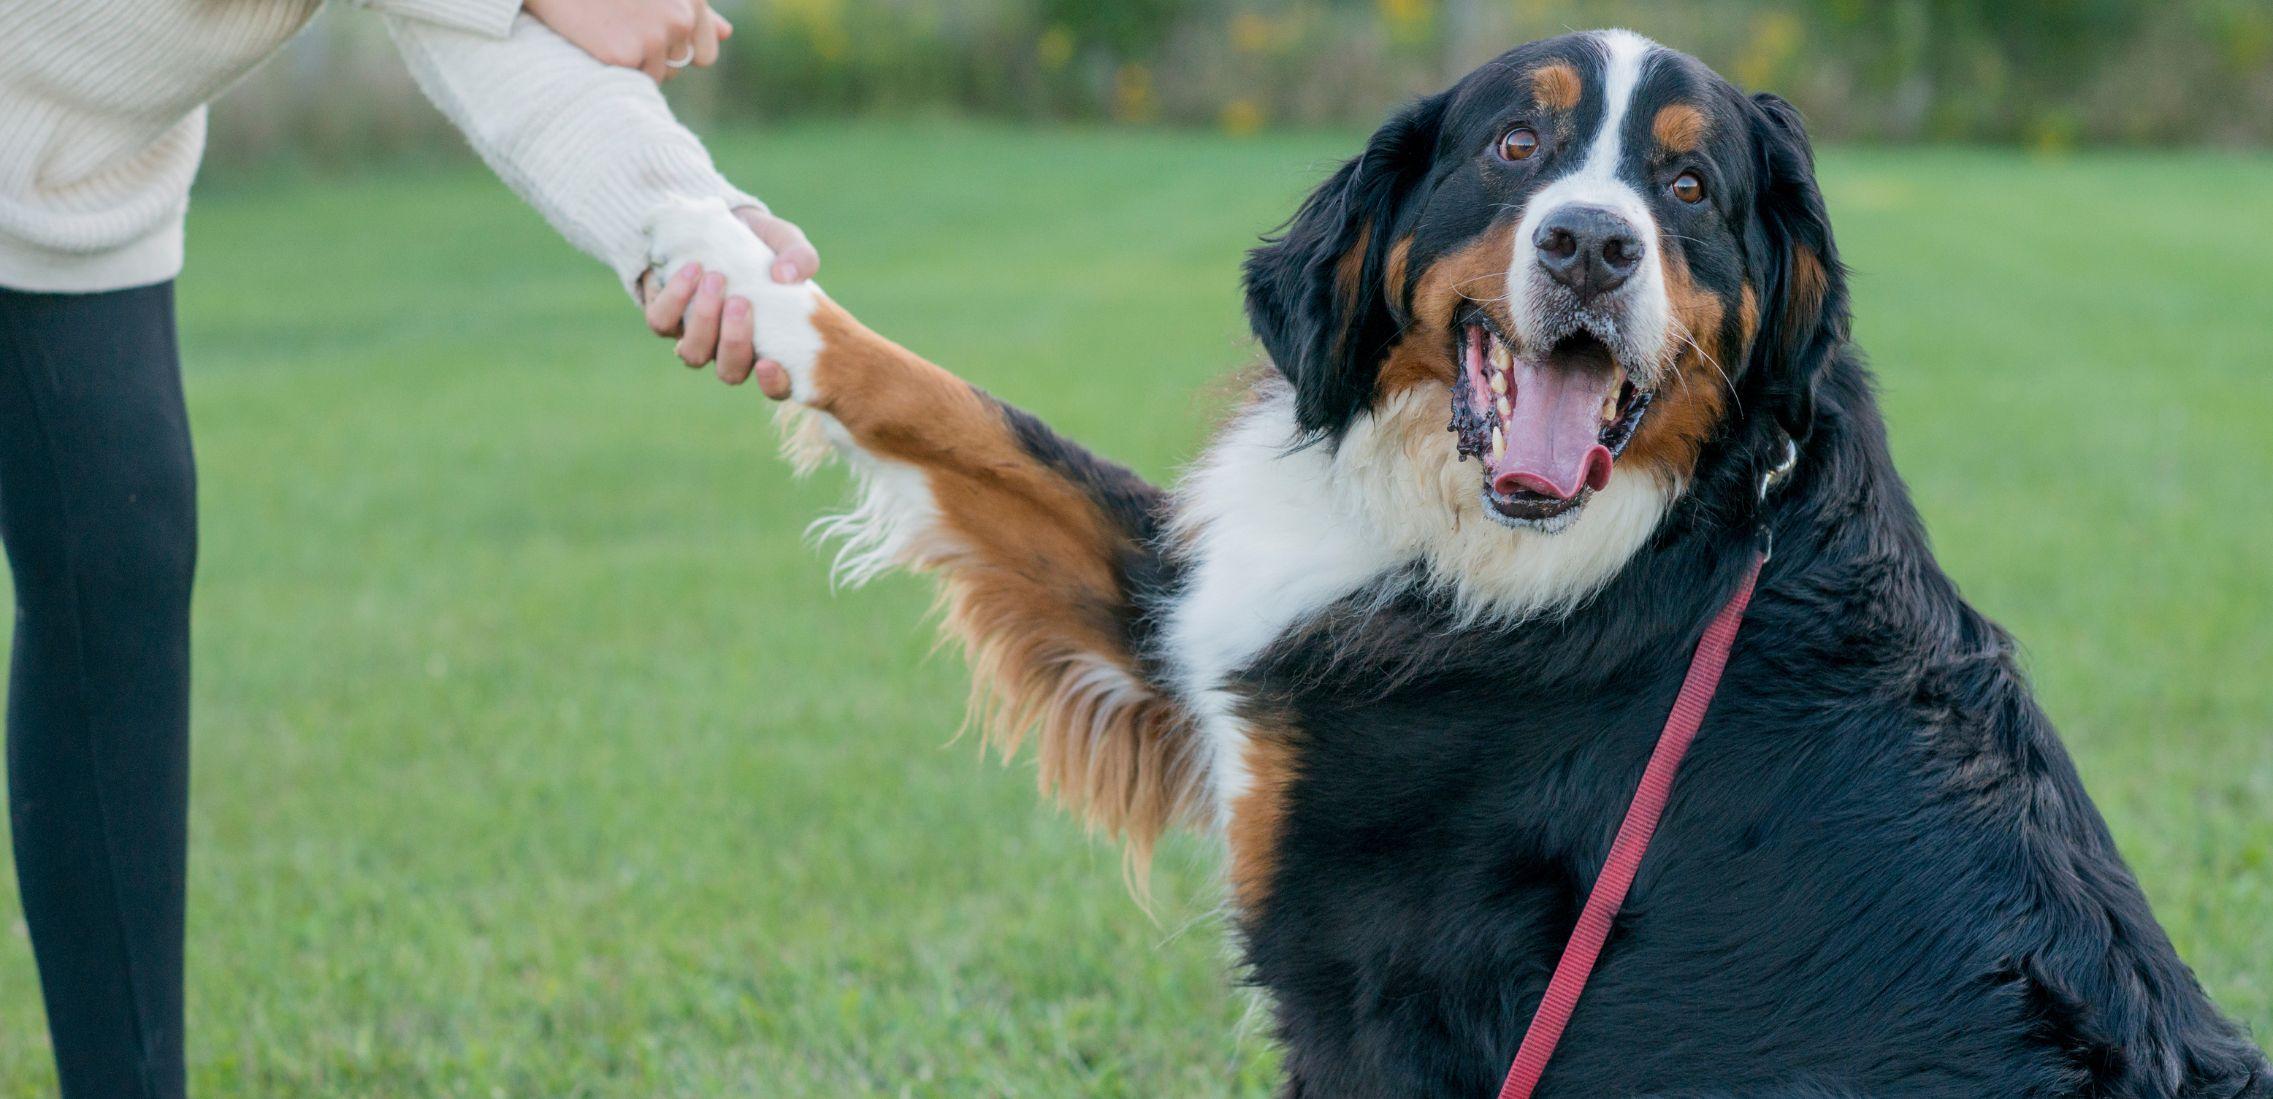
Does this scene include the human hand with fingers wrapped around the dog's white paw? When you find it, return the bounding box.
[641,207,821,390]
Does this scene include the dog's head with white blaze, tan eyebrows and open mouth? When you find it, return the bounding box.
[1246,32,1846,531]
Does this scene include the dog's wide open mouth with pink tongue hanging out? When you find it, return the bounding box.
[1452,313,1650,531]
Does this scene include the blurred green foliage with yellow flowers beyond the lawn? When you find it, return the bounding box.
[214,0,2273,163]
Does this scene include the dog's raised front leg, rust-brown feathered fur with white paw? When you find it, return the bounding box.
[650,204,1205,863]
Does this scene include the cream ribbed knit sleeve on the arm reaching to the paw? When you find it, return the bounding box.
[370,0,764,297]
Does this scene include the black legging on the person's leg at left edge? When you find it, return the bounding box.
[0,284,198,1099]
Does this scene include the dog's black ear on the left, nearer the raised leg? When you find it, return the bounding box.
[1246,95,1443,438]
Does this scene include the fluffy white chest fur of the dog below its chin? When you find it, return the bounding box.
[1164,381,1677,824]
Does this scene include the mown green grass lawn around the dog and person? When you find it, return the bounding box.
[0,123,2273,1099]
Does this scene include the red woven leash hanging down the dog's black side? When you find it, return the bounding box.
[1500,556,1766,1099]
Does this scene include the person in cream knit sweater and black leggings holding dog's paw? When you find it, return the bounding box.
[0,0,818,1099]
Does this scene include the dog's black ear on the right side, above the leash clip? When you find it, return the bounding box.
[1750,93,1848,441]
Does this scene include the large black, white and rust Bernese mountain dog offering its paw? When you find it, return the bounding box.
[652,32,2273,1099]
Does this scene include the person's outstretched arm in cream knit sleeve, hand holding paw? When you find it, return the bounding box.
[364,0,818,381]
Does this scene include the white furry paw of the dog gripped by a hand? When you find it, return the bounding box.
[648,198,823,404]
